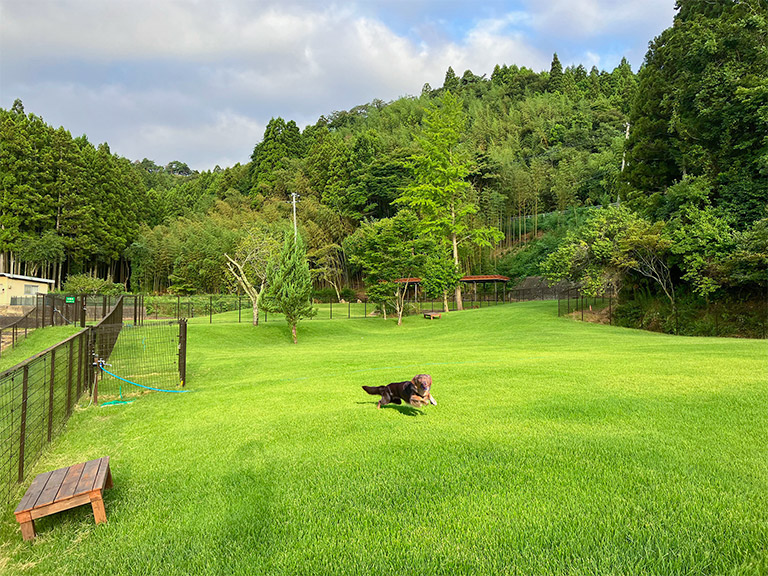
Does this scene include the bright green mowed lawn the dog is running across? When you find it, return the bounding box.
[0,302,768,576]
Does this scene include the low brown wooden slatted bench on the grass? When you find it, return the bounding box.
[14,456,112,540]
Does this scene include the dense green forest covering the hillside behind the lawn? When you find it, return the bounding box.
[0,0,768,333]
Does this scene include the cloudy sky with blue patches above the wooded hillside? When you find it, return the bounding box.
[0,0,674,170]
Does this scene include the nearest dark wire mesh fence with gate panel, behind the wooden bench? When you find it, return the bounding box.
[0,297,186,502]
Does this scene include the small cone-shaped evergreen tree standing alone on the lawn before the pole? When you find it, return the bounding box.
[265,231,317,344]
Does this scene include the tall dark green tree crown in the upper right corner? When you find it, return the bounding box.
[626,0,768,229]
